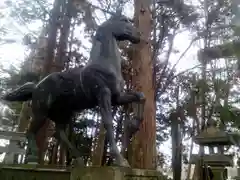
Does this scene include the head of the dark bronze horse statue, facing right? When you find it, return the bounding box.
[96,14,140,44]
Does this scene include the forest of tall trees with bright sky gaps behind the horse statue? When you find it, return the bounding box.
[0,0,240,179]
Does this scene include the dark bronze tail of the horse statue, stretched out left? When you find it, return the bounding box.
[1,82,35,101]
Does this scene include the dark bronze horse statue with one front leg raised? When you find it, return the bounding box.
[2,15,145,167]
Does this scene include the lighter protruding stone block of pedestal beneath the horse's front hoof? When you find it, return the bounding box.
[70,167,163,180]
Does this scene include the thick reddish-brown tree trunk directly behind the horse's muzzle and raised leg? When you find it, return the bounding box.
[128,0,156,169]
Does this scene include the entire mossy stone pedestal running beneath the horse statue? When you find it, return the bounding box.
[0,164,163,180]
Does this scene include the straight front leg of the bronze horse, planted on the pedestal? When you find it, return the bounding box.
[98,88,130,167]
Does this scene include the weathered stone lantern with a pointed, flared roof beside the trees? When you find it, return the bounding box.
[190,126,239,180]
